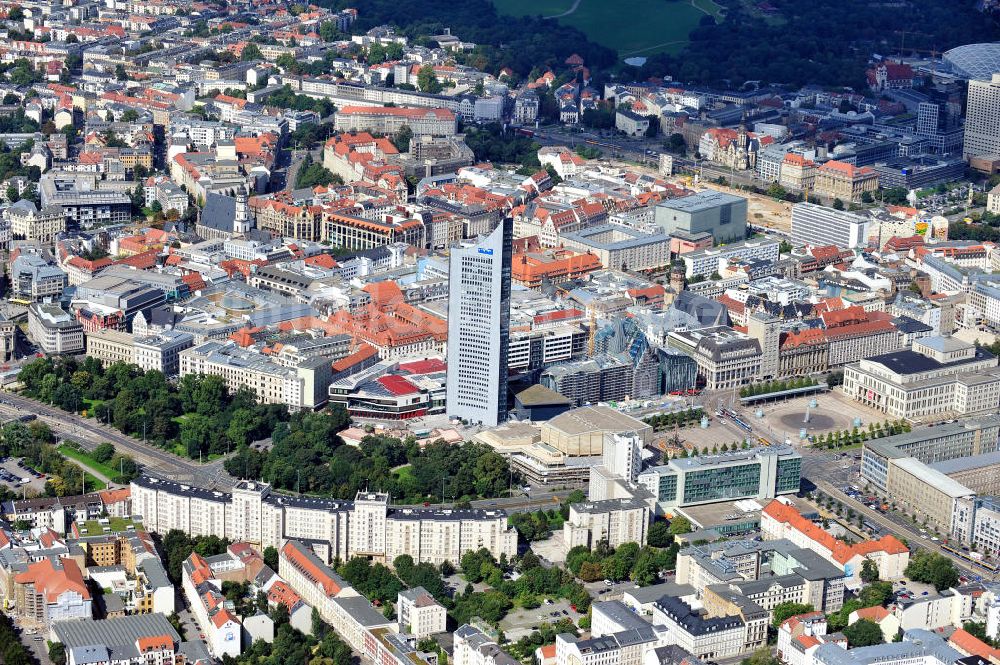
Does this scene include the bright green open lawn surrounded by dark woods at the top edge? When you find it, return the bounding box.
[493,0,719,58]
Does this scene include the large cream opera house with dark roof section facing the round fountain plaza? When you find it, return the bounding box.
[843,337,1000,420]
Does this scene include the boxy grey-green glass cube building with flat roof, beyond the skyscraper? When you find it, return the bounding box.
[653,190,747,244]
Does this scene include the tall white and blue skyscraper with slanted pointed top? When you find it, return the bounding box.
[447,218,514,426]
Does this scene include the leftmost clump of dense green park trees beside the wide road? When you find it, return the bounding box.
[19,357,292,460]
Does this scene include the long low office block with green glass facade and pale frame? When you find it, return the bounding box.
[637,446,802,512]
